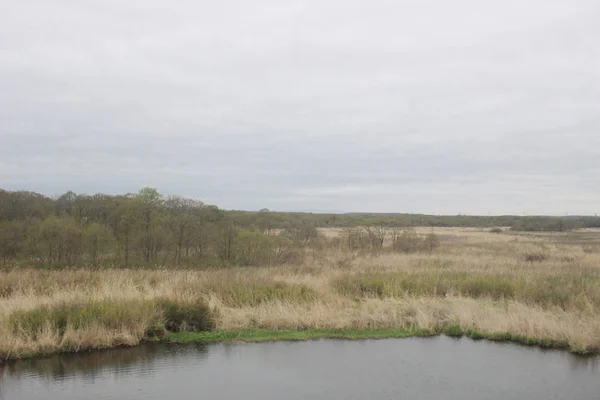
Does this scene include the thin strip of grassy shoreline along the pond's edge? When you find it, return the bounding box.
[0,325,600,366]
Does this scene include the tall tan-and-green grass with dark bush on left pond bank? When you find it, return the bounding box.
[0,298,217,360]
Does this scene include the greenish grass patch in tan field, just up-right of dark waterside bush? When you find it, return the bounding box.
[208,280,320,307]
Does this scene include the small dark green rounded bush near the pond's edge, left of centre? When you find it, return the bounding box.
[158,298,217,332]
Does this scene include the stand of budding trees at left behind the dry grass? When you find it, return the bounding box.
[0,188,290,267]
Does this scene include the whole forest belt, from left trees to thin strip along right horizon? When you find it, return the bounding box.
[0,188,600,267]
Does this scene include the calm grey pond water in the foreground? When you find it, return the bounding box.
[0,336,600,400]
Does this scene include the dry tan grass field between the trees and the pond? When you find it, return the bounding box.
[0,228,600,359]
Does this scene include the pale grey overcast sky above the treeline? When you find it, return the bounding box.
[0,0,600,215]
